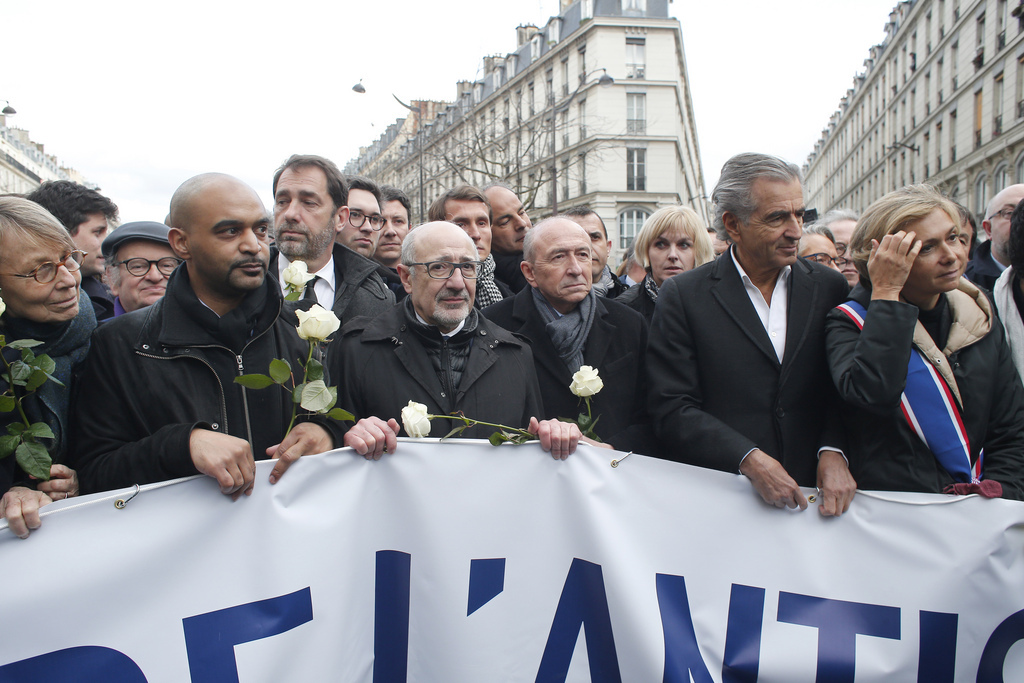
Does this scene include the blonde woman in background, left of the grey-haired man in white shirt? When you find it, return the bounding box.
[615,206,715,323]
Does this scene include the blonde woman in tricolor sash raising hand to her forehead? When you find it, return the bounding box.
[826,185,1024,500]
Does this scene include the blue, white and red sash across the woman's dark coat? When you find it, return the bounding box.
[837,301,982,483]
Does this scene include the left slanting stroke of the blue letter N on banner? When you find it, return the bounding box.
[654,573,714,683]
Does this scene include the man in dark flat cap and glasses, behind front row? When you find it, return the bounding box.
[102,221,181,317]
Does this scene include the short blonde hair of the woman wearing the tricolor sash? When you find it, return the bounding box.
[848,184,964,285]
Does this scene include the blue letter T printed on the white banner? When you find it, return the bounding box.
[778,593,900,683]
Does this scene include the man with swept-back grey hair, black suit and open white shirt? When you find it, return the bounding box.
[647,154,856,515]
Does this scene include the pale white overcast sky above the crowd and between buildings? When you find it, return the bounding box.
[0,0,895,221]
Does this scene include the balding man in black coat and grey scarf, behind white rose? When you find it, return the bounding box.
[483,216,656,455]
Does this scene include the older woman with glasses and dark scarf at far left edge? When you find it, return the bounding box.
[0,197,96,538]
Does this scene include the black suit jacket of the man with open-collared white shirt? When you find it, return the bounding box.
[647,255,849,486]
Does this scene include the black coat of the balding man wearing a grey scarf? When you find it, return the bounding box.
[483,287,656,454]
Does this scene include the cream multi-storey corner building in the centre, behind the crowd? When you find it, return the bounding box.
[345,0,709,259]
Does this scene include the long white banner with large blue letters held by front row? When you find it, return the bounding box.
[0,440,1024,683]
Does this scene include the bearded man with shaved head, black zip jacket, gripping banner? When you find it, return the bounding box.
[71,173,341,499]
